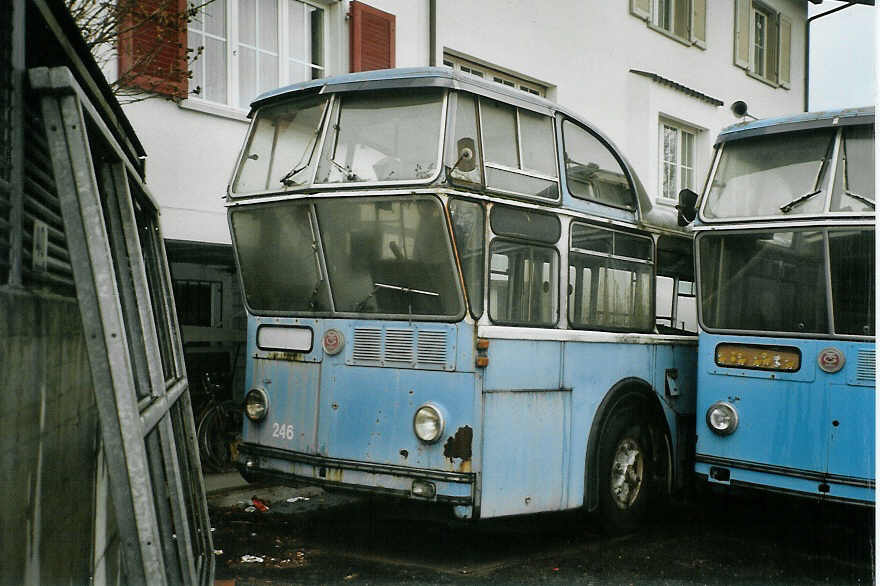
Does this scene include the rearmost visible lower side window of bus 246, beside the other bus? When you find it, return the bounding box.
[654,236,697,334]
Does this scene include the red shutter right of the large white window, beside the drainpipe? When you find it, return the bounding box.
[349,0,395,72]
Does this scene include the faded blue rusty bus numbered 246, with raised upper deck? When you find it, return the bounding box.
[227,68,697,530]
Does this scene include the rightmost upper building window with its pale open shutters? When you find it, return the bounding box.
[734,0,791,88]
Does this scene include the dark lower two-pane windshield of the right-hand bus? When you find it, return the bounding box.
[698,227,875,336]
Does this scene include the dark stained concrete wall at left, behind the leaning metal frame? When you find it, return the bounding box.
[0,288,119,585]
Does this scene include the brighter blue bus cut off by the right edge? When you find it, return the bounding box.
[682,108,876,505]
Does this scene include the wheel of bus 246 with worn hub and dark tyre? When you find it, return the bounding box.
[599,410,653,535]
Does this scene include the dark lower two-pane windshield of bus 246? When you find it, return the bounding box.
[231,196,464,319]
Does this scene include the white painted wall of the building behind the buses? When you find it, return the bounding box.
[125,0,807,243]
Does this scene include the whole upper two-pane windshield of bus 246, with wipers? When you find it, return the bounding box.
[232,89,443,194]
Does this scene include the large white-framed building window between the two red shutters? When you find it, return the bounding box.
[188,0,325,109]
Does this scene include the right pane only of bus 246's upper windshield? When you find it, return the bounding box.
[315,89,443,184]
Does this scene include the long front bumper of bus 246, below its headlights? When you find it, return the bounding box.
[238,443,475,506]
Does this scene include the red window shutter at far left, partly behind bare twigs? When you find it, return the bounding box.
[119,0,189,98]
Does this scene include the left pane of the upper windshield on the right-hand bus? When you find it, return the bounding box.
[703,128,836,220]
